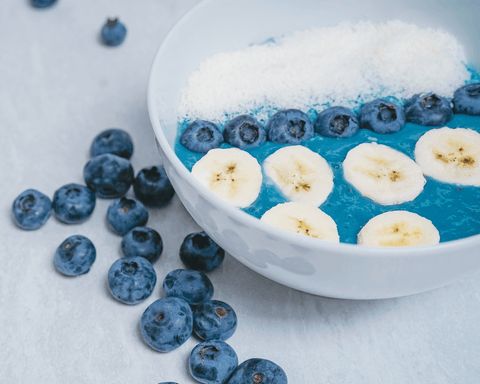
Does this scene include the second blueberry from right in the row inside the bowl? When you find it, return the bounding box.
[403,93,453,126]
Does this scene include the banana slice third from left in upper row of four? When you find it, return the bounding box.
[343,143,427,205]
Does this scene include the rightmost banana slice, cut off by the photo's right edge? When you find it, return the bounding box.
[415,127,480,187]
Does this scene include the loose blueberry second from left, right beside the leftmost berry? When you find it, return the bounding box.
[53,183,96,224]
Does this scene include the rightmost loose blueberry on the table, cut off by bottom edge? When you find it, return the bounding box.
[227,359,288,384]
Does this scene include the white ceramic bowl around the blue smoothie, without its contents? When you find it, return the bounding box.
[148,0,480,299]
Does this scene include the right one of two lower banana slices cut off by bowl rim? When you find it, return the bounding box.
[357,211,440,247]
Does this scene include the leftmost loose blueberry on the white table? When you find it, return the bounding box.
[12,189,52,231]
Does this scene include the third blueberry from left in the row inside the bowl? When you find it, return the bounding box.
[265,109,314,144]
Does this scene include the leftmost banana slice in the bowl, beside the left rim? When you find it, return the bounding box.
[192,148,262,208]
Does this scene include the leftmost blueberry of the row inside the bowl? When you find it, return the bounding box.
[180,120,223,153]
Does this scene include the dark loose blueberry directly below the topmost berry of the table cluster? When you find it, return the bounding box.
[83,153,134,199]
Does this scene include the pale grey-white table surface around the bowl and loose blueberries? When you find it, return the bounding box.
[0,0,480,384]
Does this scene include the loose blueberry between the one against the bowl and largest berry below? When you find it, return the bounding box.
[163,269,213,306]
